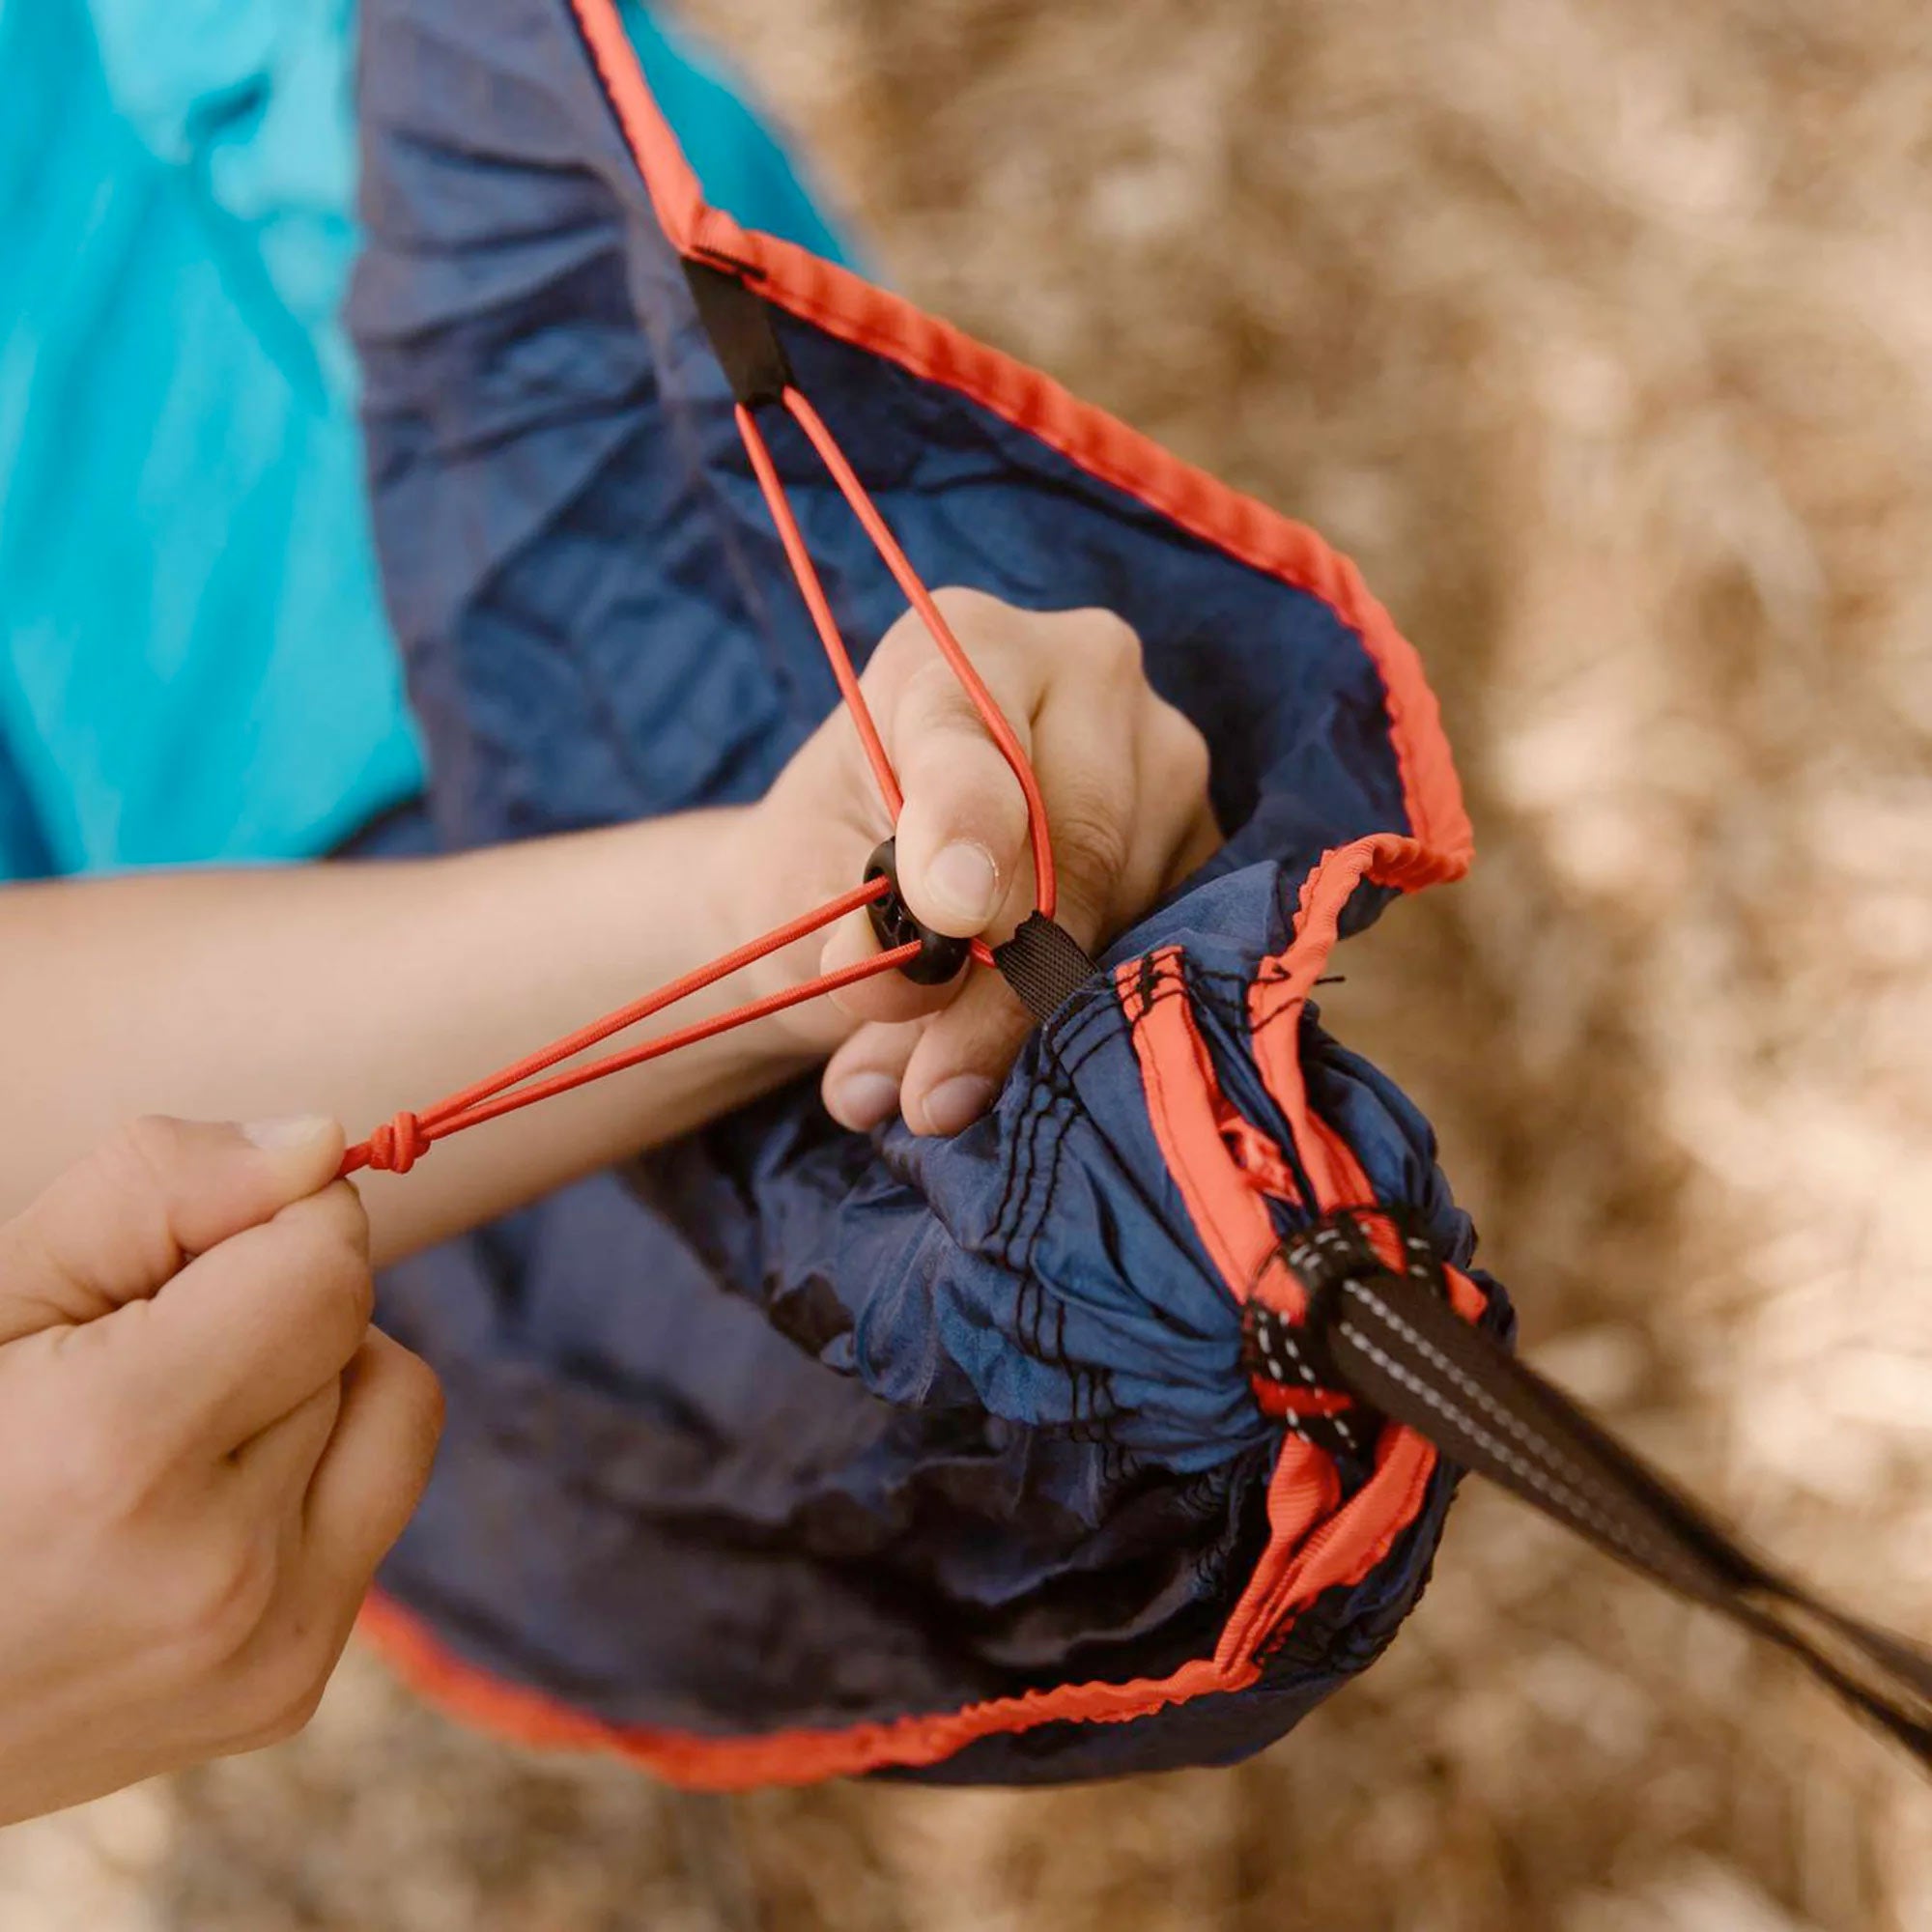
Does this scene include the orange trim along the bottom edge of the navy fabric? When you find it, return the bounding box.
[355,1592,1260,1791]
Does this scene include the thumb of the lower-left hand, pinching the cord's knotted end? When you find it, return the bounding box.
[0,1115,342,1345]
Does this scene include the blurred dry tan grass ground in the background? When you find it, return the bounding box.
[0,0,1932,1932]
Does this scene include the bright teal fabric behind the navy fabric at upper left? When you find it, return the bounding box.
[0,0,840,879]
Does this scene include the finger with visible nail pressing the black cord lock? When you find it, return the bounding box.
[889,659,1032,939]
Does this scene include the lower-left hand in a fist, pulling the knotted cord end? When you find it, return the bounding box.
[0,1121,442,1824]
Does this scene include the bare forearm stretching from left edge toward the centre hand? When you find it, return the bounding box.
[0,811,810,1260]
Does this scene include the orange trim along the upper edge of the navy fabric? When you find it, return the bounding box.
[572,0,1474,885]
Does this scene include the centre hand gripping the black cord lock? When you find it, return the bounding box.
[740,589,1221,1134]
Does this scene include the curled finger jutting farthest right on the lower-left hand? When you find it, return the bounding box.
[303,1329,442,1596]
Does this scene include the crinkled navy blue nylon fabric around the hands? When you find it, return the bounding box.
[350,0,1499,1781]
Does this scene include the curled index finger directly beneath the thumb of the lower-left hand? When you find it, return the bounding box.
[126,1180,375,1455]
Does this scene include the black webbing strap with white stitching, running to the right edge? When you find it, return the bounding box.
[1291,1242,1932,1766]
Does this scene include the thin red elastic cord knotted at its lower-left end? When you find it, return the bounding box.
[342,388,1055,1175]
